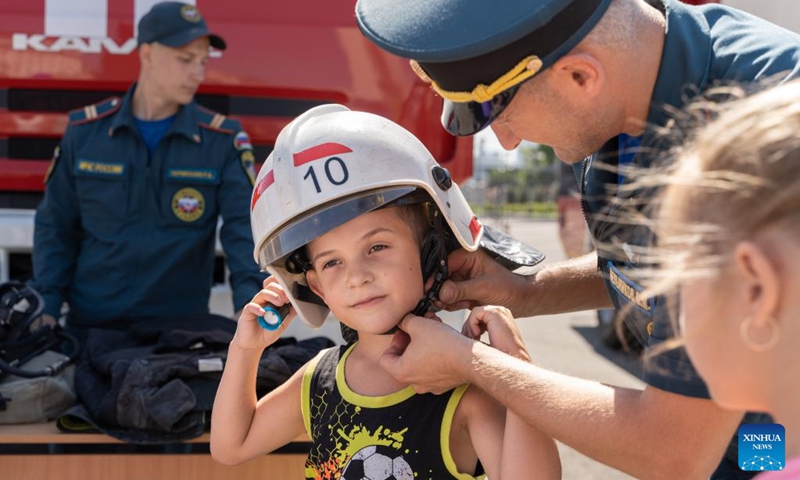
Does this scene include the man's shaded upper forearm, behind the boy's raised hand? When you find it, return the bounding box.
[514,252,612,318]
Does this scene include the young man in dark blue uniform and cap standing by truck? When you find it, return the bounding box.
[33,2,263,331]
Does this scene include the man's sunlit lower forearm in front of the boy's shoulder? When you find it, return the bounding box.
[466,344,741,479]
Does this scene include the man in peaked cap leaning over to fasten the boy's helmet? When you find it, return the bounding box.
[356,0,800,479]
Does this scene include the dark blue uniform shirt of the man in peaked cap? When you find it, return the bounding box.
[575,0,800,398]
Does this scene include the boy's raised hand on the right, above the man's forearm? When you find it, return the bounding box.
[461,305,531,362]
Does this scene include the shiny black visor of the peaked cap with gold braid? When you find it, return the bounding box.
[442,84,521,137]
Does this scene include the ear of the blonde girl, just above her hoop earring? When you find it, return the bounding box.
[734,242,781,325]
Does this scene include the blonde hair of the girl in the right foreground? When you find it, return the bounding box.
[636,80,800,300]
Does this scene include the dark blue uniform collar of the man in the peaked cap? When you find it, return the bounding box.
[647,0,711,127]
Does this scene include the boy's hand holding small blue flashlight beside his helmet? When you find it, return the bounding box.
[231,277,296,351]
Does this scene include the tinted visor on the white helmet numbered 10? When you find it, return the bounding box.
[258,185,417,268]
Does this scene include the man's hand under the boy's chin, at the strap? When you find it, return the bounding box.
[380,314,474,394]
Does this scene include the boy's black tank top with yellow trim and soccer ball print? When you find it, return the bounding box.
[302,344,484,480]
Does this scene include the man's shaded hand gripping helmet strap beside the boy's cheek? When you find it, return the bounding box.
[437,249,530,316]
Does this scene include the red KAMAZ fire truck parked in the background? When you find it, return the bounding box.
[0,0,472,309]
